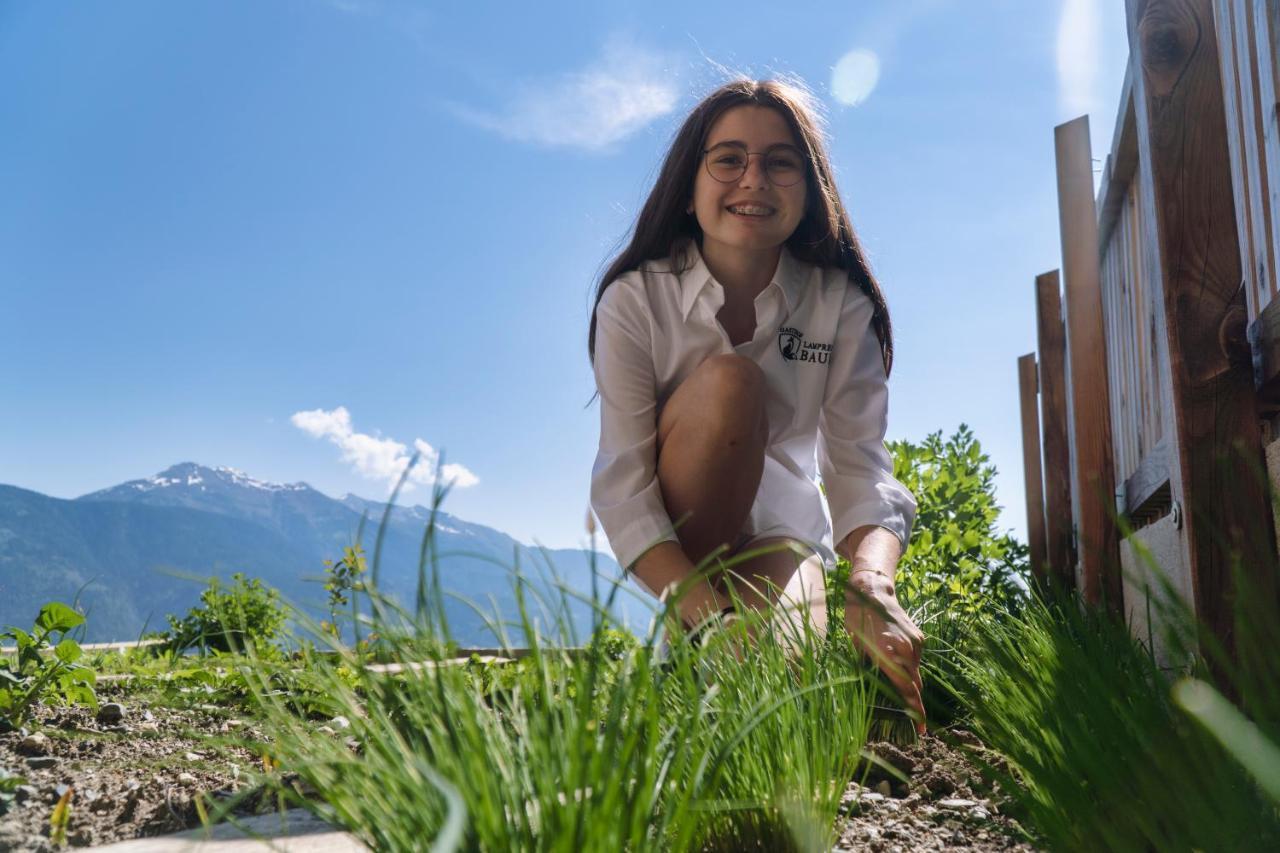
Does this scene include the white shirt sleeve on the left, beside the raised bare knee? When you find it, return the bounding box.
[591,282,678,569]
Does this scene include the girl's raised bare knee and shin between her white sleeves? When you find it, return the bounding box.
[658,355,769,573]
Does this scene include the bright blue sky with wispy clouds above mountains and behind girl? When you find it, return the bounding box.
[0,0,1126,547]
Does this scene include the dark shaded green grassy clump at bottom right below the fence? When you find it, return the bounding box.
[951,550,1280,850]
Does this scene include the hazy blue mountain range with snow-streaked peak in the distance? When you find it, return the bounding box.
[0,462,652,646]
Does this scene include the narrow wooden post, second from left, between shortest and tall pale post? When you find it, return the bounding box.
[1036,269,1075,592]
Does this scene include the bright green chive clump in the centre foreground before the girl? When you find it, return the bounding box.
[227,461,882,853]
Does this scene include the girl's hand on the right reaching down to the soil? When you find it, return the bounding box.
[845,569,925,735]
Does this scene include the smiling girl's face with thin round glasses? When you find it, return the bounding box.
[690,105,809,262]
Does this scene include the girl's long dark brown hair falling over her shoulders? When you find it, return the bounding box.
[586,79,893,377]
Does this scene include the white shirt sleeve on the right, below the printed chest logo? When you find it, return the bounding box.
[818,286,915,549]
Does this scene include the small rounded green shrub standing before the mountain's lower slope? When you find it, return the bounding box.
[165,573,285,653]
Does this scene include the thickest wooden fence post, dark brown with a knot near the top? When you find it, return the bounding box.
[1126,0,1277,662]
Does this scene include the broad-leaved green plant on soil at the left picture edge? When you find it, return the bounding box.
[0,602,97,727]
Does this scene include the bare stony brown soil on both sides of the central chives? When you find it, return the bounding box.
[0,685,1036,853]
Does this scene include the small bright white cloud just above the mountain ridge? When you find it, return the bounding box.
[289,406,480,492]
